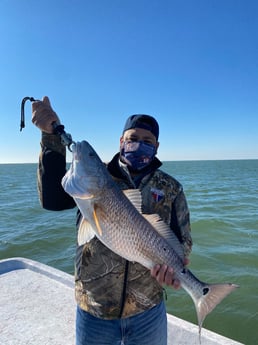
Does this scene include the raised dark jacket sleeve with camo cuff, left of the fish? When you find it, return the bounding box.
[37,132,75,211]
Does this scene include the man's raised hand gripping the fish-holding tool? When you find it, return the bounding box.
[32,96,60,133]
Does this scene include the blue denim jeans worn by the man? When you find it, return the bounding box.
[76,302,167,345]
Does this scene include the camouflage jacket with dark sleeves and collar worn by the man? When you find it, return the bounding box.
[38,134,192,319]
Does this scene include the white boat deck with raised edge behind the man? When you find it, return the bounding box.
[0,258,240,345]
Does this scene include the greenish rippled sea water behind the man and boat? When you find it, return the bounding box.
[0,160,258,345]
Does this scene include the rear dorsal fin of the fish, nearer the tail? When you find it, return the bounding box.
[143,214,185,261]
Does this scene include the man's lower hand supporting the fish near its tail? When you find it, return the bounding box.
[151,258,189,290]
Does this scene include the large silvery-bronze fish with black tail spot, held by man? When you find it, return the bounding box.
[62,141,238,333]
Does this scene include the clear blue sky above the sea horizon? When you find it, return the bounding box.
[0,0,258,163]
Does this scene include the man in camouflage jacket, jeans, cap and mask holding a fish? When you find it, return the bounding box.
[32,97,192,345]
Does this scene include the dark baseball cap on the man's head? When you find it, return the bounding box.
[123,114,159,140]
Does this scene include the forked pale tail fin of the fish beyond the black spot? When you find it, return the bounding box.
[195,283,239,335]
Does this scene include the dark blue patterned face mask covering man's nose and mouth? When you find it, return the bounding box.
[121,141,156,171]
